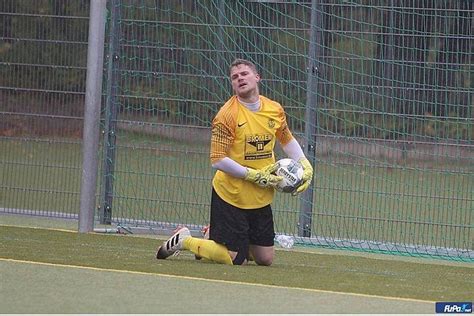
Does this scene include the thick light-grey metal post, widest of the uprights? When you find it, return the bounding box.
[79,0,107,233]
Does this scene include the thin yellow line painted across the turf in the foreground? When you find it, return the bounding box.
[0,258,435,303]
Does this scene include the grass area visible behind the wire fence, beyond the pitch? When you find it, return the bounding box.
[0,133,474,256]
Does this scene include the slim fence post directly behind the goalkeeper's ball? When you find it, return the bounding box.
[298,0,323,237]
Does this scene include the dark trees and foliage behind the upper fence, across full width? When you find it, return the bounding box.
[0,0,474,141]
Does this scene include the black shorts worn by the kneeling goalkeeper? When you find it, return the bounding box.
[209,188,275,257]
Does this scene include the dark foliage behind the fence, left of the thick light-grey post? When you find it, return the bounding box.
[0,0,88,91]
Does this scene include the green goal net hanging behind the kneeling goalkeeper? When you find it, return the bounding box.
[103,1,474,257]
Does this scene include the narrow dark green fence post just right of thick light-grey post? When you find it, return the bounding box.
[99,0,121,224]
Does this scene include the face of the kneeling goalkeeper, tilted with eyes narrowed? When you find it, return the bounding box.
[230,64,260,98]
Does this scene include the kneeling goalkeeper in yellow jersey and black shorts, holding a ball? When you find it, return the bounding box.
[157,59,313,266]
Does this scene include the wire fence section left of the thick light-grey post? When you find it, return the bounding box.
[0,1,89,218]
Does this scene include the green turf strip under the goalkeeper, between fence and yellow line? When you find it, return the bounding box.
[0,226,474,301]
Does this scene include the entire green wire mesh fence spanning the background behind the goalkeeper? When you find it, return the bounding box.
[0,0,474,261]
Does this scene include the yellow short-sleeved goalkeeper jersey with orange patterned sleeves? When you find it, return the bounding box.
[211,96,293,209]
